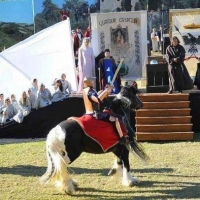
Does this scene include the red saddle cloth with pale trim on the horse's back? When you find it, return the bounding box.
[70,115,127,152]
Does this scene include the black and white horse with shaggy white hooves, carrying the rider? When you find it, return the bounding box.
[40,86,146,194]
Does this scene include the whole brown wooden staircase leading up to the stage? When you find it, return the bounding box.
[136,93,193,141]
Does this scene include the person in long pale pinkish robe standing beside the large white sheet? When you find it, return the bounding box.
[78,38,95,92]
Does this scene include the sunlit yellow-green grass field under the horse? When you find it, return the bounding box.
[0,134,200,200]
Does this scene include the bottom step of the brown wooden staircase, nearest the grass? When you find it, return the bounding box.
[137,131,194,141]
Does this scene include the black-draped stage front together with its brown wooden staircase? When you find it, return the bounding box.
[0,90,200,141]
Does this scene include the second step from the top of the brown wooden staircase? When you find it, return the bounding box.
[143,101,190,109]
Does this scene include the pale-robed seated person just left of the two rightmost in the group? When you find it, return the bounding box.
[35,83,52,109]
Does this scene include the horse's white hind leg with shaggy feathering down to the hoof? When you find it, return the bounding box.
[41,125,78,194]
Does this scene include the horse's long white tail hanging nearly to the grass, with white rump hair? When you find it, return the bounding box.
[40,125,70,190]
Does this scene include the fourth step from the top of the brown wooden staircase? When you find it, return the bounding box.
[136,116,192,125]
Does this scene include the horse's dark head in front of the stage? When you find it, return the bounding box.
[114,86,143,110]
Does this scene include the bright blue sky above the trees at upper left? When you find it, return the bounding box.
[0,0,95,24]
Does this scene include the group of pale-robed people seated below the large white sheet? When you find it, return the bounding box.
[0,74,73,124]
